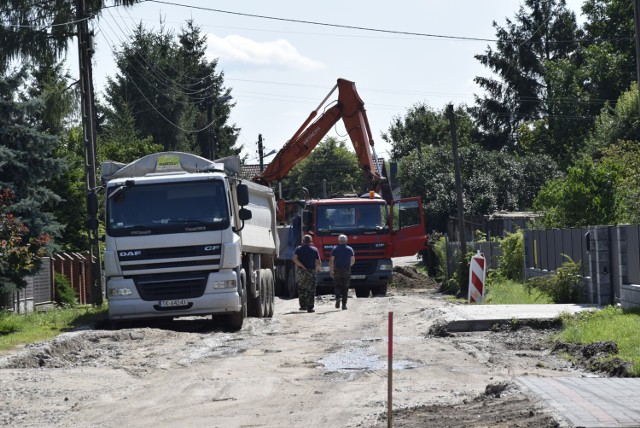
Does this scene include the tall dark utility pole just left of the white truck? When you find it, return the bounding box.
[76,0,103,305]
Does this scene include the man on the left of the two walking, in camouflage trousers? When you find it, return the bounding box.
[292,235,320,312]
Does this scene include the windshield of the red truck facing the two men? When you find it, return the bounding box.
[316,202,389,235]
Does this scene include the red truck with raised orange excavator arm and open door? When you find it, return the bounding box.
[253,79,427,297]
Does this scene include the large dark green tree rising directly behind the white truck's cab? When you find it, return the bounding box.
[105,21,241,157]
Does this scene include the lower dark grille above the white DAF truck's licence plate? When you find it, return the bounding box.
[133,272,208,300]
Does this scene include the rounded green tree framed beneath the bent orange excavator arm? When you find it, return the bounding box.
[282,137,365,199]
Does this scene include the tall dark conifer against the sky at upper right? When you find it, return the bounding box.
[472,0,580,150]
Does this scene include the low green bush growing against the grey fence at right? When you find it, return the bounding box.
[525,254,582,303]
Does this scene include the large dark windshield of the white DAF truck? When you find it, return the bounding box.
[107,180,229,236]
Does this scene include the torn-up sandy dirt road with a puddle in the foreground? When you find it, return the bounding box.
[0,289,580,428]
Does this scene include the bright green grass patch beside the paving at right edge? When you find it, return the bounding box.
[556,306,640,376]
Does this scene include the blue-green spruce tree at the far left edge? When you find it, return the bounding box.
[0,71,61,291]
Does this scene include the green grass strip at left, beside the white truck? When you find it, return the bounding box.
[0,305,107,352]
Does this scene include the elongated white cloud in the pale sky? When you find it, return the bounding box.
[207,34,324,71]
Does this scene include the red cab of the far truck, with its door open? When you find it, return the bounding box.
[278,192,427,297]
